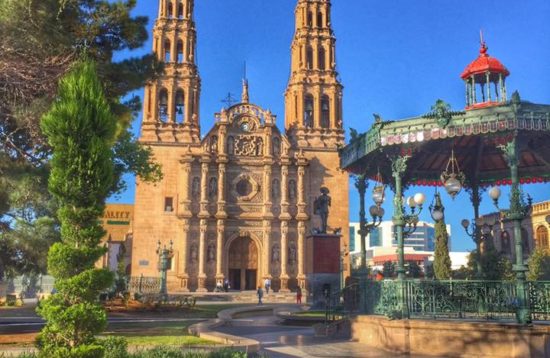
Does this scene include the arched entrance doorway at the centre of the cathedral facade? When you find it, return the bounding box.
[228,237,258,290]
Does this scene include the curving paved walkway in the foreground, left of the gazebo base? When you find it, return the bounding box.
[214,306,416,358]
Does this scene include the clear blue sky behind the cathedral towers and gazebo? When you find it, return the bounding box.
[110,0,550,250]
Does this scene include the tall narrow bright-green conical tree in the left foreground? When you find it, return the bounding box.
[37,61,117,358]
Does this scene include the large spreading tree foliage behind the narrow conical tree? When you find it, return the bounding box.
[0,0,162,278]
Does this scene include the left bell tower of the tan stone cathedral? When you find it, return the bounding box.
[140,0,201,144]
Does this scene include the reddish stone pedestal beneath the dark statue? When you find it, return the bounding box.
[307,234,343,308]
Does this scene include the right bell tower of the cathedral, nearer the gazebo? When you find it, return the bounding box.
[285,0,344,148]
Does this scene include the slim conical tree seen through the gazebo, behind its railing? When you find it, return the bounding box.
[433,193,452,280]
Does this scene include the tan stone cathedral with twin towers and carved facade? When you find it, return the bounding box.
[131,0,349,293]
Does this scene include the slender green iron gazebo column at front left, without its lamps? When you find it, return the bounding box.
[392,156,409,318]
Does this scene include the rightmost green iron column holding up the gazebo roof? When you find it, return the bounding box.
[500,135,531,324]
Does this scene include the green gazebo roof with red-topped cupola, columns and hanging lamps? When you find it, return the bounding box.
[340,41,550,323]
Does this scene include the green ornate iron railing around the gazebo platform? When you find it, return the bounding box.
[363,280,550,320]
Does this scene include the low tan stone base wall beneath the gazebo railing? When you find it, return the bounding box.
[351,316,550,358]
